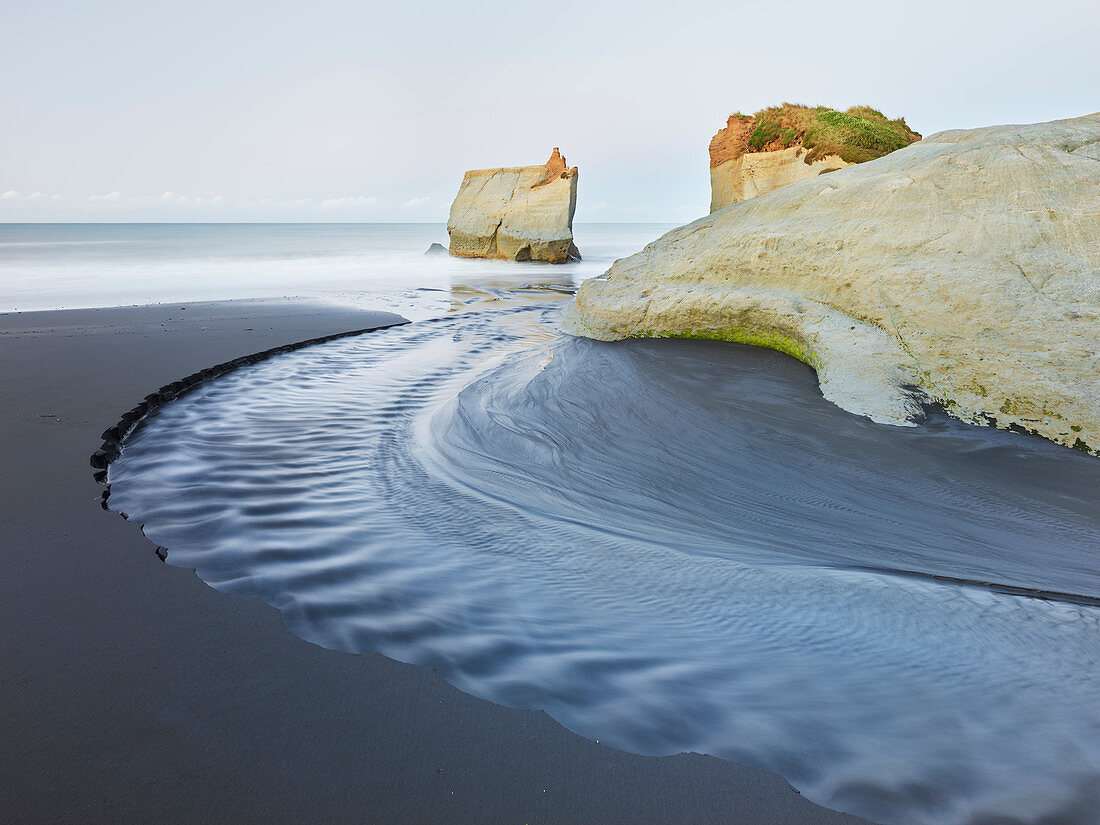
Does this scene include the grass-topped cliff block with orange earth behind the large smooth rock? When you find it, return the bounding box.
[711,103,921,212]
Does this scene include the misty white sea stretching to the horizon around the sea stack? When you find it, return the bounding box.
[0,223,672,320]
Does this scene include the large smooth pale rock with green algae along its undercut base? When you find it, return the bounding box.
[567,113,1100,452]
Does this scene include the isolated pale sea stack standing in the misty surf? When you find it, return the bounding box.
[447,149,580,264]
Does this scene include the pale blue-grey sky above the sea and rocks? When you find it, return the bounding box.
[0,0,1100,222]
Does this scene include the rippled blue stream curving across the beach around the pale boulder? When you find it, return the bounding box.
[110,287,1100,823]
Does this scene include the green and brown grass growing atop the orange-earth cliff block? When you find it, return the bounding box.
[748,103,921,163]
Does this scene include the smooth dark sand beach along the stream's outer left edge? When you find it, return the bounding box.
[0,301,861,824]
